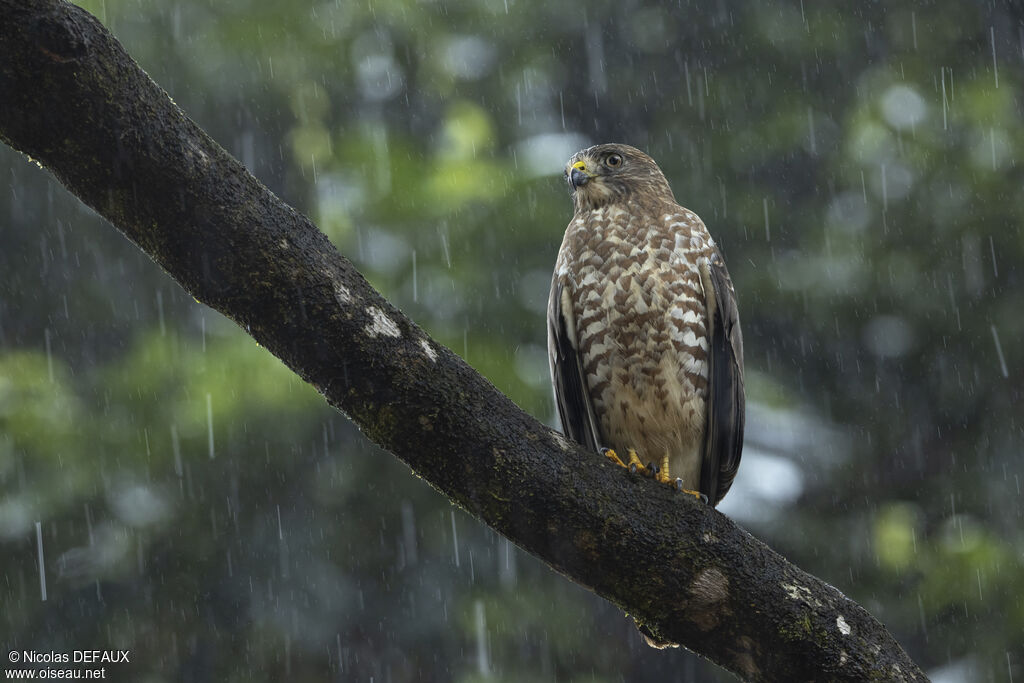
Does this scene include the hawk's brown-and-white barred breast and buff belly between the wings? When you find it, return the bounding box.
[556,200,715,487]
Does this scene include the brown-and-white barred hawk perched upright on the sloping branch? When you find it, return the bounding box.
[548,144,743,505]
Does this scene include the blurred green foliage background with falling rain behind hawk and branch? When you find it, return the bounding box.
[0,0,1024,681]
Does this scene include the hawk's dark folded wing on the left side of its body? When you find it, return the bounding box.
[548,272,600,451]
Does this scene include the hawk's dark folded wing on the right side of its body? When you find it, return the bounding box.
[700,249,744,505]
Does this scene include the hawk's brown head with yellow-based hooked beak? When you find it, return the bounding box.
[565,143,676,211]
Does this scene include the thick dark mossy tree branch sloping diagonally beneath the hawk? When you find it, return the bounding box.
[0,0,927,681]
